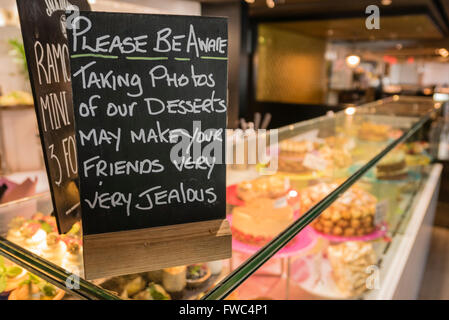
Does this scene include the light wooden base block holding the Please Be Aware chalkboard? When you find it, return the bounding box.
[83,219,232,280]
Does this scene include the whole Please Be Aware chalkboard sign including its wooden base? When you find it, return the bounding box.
[67,11,232,279]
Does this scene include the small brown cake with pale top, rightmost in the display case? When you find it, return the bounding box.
[376,149,408,180]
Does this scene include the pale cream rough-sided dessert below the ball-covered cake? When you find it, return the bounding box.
[327,241,376,297]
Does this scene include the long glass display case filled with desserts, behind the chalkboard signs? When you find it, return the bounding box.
[0,96,441,300]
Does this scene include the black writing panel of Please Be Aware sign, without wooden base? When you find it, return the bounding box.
[69,12,228,235]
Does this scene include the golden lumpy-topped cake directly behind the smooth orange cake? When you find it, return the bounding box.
[237,176,290,201]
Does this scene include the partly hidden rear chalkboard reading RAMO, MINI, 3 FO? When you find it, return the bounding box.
[17,0,90,232]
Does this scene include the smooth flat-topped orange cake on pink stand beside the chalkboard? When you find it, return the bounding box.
[232,198,294,246]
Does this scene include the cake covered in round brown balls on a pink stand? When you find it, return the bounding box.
[300,183,377,237]
